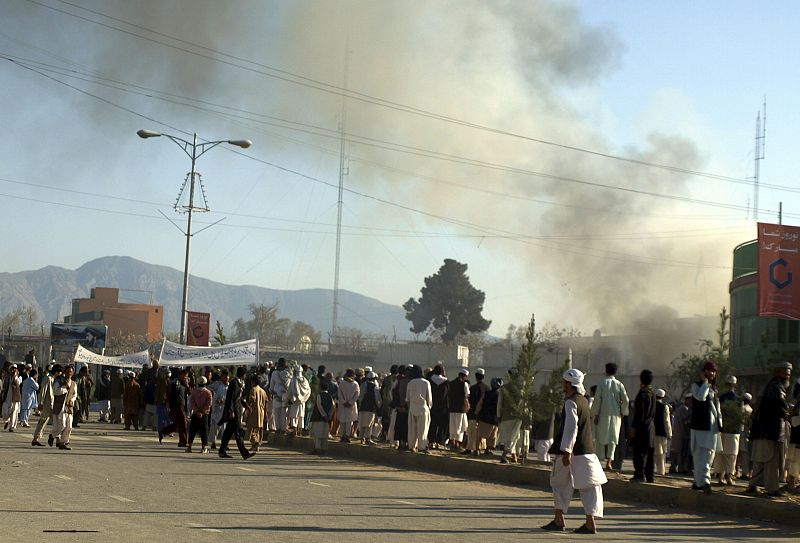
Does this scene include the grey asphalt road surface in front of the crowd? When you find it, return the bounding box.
[0,423,800,543]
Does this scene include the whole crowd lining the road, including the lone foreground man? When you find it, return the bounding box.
[0,353,800,533]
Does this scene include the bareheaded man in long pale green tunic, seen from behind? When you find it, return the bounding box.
[591,362,630,470]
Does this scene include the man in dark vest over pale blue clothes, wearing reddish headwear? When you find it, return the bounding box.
[689,362,722,494]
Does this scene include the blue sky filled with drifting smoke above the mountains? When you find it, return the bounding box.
[0,0,800,335]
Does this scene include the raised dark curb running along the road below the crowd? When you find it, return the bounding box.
[267,436,800,527]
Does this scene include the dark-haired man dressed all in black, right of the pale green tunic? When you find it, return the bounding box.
[629,370,656,483]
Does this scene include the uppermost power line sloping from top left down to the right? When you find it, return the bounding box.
[28,0,790,190]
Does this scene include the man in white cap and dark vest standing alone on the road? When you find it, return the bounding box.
[542,369,607,534]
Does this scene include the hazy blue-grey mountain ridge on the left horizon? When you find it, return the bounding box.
[0,256,410,338]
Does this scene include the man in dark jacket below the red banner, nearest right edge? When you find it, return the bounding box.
[747,362,792,496]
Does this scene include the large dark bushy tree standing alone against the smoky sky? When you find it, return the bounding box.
[403,258,492,343]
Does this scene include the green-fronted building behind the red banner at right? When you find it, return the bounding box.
[729,240,800,376]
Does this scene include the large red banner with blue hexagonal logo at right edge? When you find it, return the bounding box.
[758,223,800,320]
